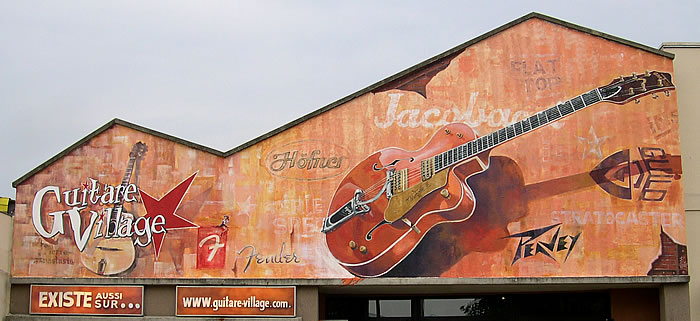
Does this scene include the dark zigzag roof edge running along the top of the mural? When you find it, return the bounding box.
[12,12,674,188]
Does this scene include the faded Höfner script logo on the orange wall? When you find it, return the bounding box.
[265,139,350,180]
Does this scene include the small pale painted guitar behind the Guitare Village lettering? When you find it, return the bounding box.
[80,142,148,276]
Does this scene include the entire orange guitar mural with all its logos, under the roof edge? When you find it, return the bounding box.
[12,18,687,279]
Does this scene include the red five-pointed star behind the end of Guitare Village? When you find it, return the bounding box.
[139,172,199,260]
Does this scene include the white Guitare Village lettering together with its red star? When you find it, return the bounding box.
[32,172,199,258]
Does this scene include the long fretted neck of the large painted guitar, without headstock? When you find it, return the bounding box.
[432,88,603,173]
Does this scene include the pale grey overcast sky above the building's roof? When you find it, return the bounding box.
[0,0,700,198]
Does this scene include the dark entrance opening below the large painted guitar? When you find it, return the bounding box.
[321,292,612,321]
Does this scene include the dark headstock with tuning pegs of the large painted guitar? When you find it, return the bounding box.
[598,70,676,104]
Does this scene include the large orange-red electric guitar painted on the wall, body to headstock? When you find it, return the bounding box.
[321,71,675,277]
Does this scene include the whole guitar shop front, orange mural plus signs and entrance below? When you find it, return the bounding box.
[9,14,690,321]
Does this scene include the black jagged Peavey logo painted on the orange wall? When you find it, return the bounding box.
[506,223,581,265]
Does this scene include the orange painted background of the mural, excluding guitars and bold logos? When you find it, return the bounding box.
[12,19,687,278]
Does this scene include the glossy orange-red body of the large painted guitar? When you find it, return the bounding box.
[326,124,488,277]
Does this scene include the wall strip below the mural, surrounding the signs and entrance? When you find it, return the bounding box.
[6,276,690,321]
